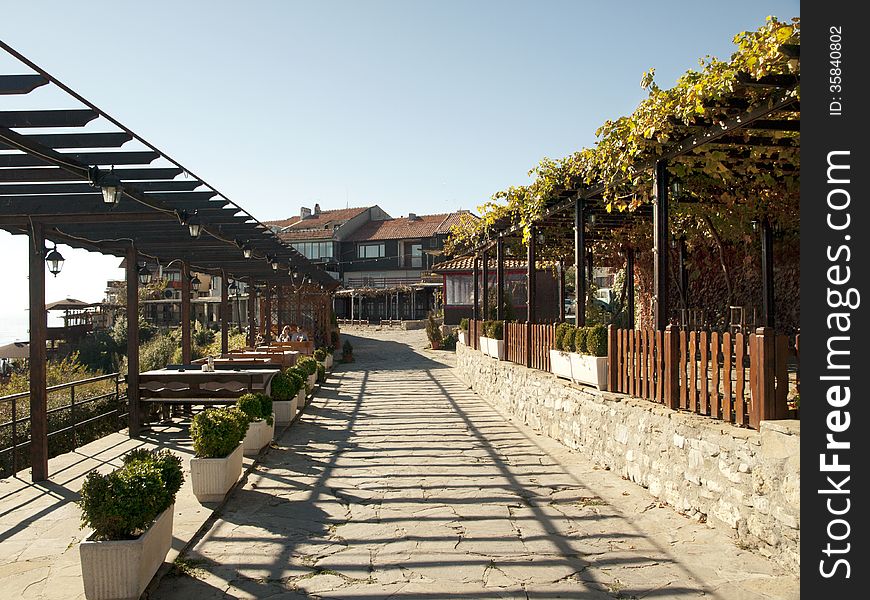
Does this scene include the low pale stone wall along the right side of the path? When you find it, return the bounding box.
[456,344,800,571]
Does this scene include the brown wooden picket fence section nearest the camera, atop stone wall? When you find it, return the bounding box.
[608,326,800,429]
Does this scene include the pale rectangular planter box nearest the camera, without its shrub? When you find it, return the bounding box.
[79,504,175,600]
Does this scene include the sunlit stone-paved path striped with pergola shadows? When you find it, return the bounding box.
[150,332,799,600]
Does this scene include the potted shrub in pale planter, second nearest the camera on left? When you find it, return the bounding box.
[190,406,248,502]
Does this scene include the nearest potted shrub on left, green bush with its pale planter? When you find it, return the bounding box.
[78,449,184,600]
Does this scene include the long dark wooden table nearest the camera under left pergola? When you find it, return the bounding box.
[139,365,280,405]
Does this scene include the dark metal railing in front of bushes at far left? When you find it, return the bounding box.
[0,373,127,477]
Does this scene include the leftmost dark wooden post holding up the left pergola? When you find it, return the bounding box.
[27,221,48,482]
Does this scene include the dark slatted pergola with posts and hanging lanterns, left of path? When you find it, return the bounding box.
[0,41,338,481]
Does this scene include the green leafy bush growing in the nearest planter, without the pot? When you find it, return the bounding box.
[78,449,184,540]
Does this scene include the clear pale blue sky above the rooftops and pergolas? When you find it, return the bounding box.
[0,0,799,343]
